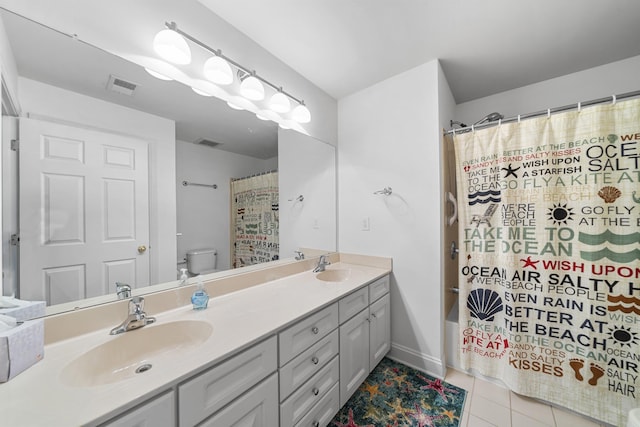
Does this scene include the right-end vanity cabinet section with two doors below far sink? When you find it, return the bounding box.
[340,276,391,406]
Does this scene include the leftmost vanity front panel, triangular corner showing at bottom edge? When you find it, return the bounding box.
[102,391,176,427]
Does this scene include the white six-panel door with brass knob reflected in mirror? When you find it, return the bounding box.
[19,119,149,305]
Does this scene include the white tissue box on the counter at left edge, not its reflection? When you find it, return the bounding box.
[0,319,44,383]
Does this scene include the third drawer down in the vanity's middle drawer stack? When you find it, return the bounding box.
[280,356,340,427]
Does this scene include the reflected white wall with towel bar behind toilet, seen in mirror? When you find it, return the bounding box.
[174,141,278,272]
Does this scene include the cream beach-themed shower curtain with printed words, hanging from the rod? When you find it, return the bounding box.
[454,100,640,425]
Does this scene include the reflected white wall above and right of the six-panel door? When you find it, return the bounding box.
[18,77,176,283]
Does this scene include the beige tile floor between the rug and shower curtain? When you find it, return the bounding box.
[445,368,607,427]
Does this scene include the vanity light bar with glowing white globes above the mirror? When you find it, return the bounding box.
[154,22,311,123]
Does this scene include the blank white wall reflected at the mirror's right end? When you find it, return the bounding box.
[278,130,337,258]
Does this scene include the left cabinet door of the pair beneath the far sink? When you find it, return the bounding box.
[340,309,369,406]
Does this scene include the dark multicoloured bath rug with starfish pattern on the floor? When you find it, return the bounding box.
[329,358,467,427]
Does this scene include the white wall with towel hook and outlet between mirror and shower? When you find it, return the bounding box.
[338,61,444,375]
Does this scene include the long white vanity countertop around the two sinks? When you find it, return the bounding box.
[0,262,391,427]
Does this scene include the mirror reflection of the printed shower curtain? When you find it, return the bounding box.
[231,172,279,268]
